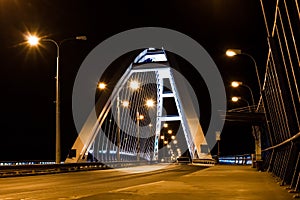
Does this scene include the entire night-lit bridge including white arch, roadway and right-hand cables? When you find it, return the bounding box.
[0,0,300,199]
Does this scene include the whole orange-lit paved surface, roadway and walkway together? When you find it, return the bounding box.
[0,164,293,200]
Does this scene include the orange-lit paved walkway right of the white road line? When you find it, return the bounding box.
[102,165,294,200]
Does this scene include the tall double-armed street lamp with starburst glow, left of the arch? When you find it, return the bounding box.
[27,34,87,164]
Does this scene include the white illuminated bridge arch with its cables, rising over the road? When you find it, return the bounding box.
[66,48,211,162]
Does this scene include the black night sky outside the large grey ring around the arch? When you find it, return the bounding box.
[0,0,267,160]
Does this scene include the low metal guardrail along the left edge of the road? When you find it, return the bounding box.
[0,161,148,178]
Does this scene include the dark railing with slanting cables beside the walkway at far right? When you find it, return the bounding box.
[260,0,300,197]
